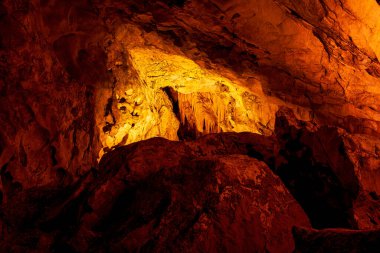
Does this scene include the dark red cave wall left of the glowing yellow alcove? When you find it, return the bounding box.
[0,1,108,193]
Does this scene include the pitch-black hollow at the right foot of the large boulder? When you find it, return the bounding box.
[277,157,355,228]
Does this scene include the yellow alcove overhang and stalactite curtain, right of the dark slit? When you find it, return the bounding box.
[130,48,274,133]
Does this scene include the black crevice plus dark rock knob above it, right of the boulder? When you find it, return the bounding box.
[276,113,357,229]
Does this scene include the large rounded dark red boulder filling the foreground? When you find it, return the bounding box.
[0,133,310,252]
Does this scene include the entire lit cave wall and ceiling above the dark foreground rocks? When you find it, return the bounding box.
[5,0,379,188]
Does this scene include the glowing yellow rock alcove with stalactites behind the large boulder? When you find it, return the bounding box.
[97,24,277,156]
